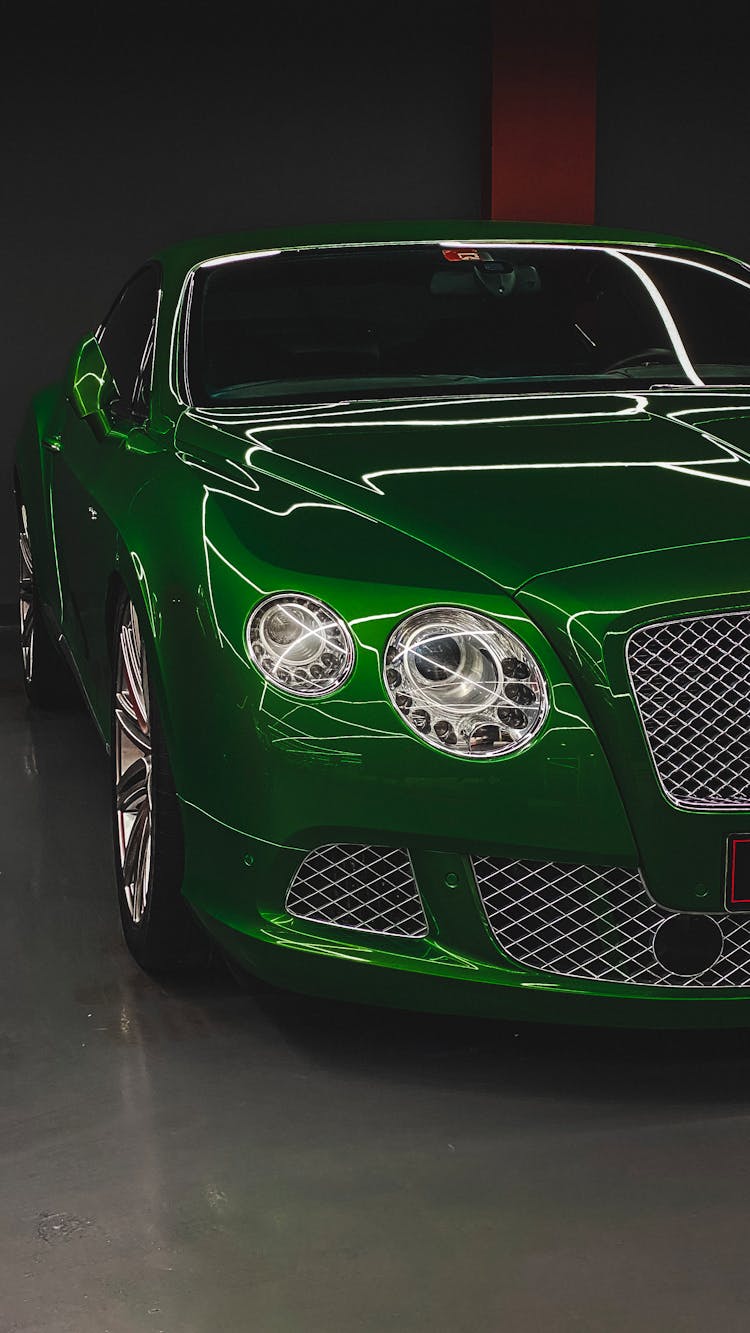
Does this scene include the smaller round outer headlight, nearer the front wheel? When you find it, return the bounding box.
[245,592,354,696]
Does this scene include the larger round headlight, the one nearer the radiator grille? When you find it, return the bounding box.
[385,607,549,758]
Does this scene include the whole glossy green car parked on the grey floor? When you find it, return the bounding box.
[15,223,750,1026]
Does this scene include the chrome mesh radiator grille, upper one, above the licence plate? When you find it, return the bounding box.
[627,612,750,809]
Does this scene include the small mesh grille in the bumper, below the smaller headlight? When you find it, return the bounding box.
[285,846,428,938]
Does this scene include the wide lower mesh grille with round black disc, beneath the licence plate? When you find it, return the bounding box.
[473,857,750,989]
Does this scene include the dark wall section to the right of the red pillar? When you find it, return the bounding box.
[597,0,750,259]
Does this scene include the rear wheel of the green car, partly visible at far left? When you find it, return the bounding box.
[17,497,80,708]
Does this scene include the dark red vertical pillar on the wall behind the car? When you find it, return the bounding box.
[489,0,598,223]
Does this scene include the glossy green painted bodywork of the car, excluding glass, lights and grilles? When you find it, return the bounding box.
[16,223,750,1025]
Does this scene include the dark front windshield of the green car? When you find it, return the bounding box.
[187,244,750,408]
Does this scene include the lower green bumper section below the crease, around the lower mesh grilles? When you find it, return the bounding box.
[177,802,750,1028]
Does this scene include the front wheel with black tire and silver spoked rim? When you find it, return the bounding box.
[112,596,208,973]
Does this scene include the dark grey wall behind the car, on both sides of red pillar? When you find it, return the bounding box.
[8,0,750,603]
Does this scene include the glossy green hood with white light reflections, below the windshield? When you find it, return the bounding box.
[177,391,750,592]
